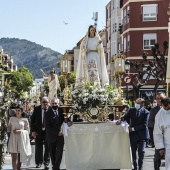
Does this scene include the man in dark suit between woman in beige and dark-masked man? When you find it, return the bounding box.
[31,97,50,169]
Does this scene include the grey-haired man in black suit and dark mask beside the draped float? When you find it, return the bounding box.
[45,98,64,170]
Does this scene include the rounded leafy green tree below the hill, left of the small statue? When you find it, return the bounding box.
[9,66,33,98]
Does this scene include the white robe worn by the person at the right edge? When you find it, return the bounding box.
[153,108,170,170]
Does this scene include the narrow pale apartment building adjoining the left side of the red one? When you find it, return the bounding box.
[106,0,123,84]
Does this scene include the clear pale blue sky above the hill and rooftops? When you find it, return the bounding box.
[0,0,109,54]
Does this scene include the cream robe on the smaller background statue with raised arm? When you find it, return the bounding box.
[48,74,60,101]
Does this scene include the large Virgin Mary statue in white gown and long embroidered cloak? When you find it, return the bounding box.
[75,25,109,87]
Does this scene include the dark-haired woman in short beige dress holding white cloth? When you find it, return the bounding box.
[8,106,31,170]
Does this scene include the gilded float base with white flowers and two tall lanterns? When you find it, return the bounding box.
[60,52,127,123]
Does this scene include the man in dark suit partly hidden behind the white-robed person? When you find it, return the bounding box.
[148,92,166,170]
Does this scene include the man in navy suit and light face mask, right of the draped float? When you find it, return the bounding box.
[117,98,149,170]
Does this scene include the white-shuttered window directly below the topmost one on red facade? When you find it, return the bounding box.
[143,33,156,50]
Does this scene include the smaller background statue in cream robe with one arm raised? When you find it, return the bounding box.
[40,68,60,101]
